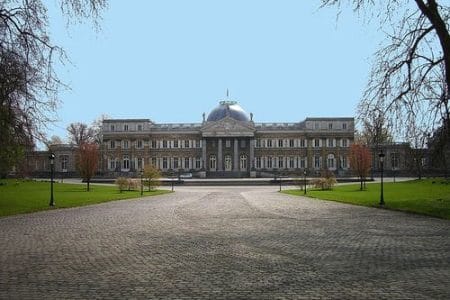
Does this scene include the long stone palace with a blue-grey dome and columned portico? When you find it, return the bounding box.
[100,100,355,178]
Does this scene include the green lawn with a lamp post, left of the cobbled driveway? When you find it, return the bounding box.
[0,179,170,216]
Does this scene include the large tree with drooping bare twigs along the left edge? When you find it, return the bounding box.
[0,0,107,175]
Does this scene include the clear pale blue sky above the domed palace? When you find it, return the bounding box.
[48,0,382,142]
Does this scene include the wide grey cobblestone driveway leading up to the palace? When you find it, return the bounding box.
[0,187,450,299]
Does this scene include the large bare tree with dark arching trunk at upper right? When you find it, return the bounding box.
[322,0,450,144]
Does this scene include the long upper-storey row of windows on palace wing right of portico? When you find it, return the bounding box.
[255,138,350,148]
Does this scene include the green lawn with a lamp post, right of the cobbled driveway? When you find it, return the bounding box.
[284,179,450,219]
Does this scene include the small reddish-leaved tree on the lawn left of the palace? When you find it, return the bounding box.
[76,143,99,191]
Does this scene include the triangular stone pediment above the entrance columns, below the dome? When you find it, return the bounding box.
[201,117,255,137]
